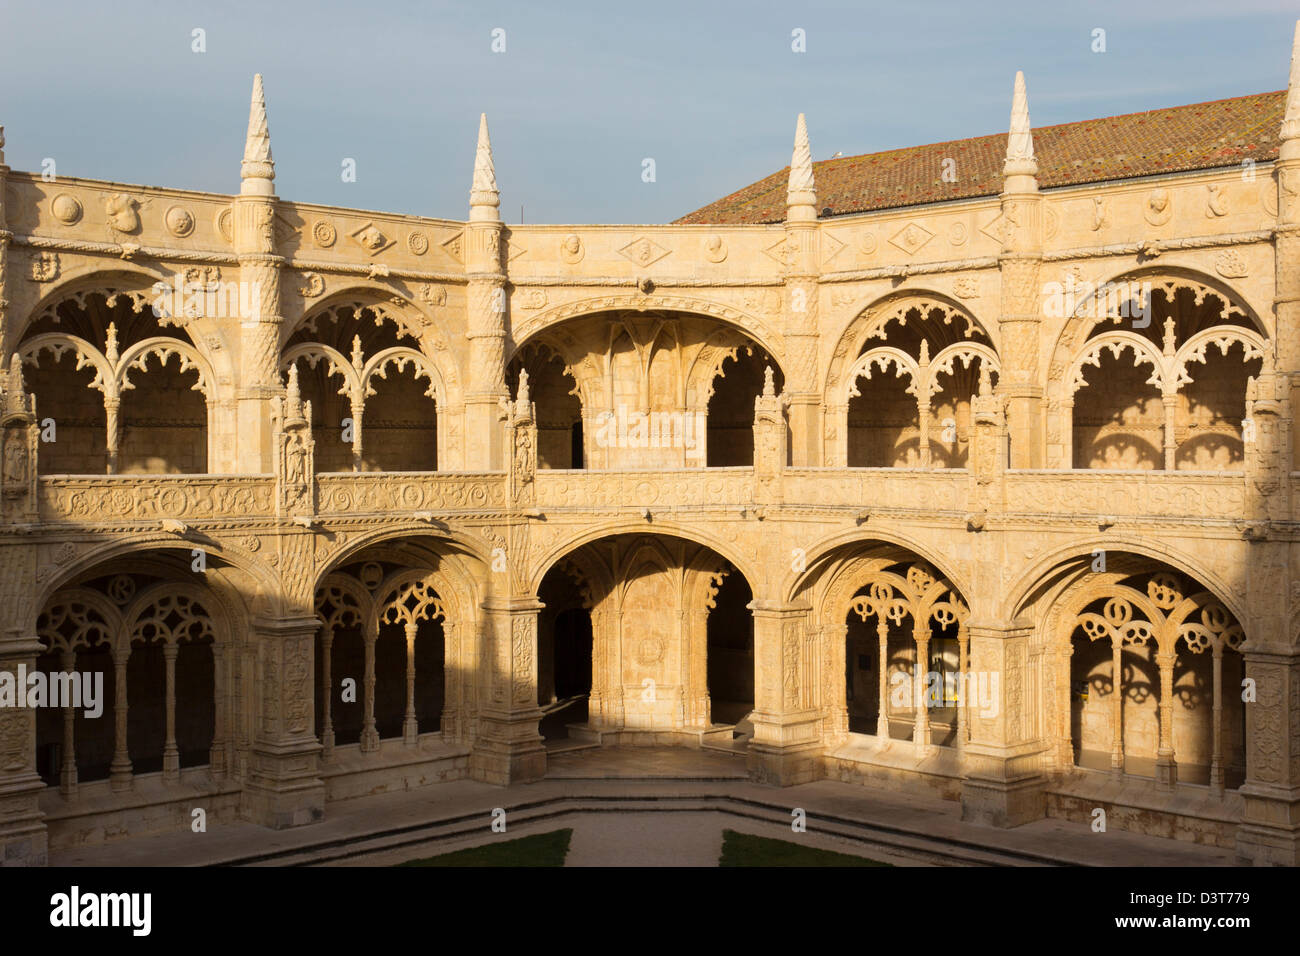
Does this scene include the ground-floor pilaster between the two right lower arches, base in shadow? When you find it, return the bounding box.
[962,624,1047,827]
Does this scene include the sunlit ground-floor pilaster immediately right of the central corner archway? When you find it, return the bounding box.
[746,601,822,787]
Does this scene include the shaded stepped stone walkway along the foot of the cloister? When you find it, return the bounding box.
[49,748,1234,866]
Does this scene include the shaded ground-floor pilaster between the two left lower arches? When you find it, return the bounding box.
[241,617,325,830]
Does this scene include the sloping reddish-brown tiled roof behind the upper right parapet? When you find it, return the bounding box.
[677,90,1286,224]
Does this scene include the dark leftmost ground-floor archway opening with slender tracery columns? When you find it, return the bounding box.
[36,551,233,796]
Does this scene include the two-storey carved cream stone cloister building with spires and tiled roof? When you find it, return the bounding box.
[0,29,1300,864]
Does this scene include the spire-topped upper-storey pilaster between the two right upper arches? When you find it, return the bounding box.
[997,73,1043,468]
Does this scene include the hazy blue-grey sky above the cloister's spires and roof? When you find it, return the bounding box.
[0,0,1300,222]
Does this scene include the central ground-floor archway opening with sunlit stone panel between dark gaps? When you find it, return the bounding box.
[538,533,755,749]
